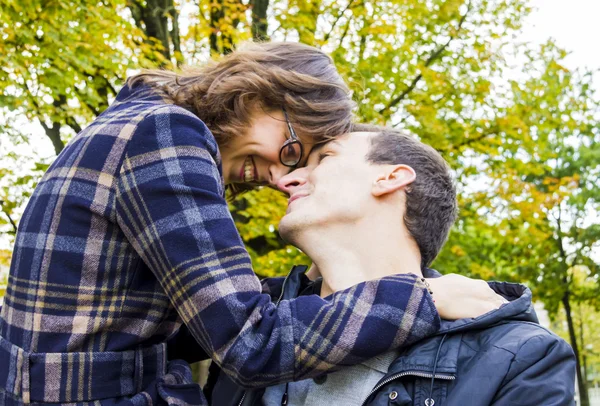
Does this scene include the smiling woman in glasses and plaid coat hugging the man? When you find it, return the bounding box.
[0,43,499,405]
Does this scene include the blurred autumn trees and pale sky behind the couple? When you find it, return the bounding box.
[0,0,600,405]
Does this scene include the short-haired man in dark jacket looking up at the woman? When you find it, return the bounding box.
[207,129,575,406]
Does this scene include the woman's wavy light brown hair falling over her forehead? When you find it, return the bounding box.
[128,42,354,147]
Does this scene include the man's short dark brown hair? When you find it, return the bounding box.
[352,124,458,267]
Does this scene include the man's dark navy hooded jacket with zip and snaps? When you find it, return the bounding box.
[207,268,575,406]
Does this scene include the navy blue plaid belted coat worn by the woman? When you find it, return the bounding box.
[0,86,439,404]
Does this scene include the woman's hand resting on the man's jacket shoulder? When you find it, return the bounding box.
[426,274,508,320]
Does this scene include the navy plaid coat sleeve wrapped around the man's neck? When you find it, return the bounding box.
[116,106,440,387]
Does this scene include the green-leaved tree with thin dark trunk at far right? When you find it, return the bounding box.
[436,42,600,405]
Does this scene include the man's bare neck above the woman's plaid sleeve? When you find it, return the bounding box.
[300,220,422,297]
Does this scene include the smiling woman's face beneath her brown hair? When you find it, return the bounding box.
[221,109,306,186]
